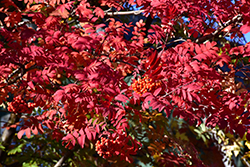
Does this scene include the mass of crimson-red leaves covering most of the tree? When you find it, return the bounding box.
[0,0,250,165]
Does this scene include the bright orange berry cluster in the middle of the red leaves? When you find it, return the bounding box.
[131,76,161,95]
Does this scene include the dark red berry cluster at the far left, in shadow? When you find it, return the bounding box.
[8,95,36,114]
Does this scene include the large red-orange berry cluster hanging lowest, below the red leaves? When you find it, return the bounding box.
[95,135,139,162]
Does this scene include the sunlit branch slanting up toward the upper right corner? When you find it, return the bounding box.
[195,14,242,43]
